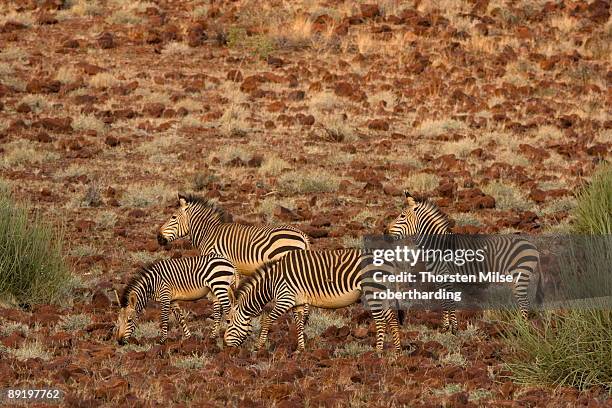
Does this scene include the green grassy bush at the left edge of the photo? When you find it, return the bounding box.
[0,184,72,305]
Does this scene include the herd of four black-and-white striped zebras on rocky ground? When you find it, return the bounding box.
[115,192,539,352]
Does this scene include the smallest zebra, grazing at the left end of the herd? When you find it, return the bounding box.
[116,254,236,344]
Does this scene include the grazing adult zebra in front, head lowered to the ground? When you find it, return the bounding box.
[224,249,403,352]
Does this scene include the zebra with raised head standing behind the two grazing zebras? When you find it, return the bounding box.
[157,193,310,275]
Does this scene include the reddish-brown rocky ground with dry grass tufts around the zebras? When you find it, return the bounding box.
[0,0,612,407]
